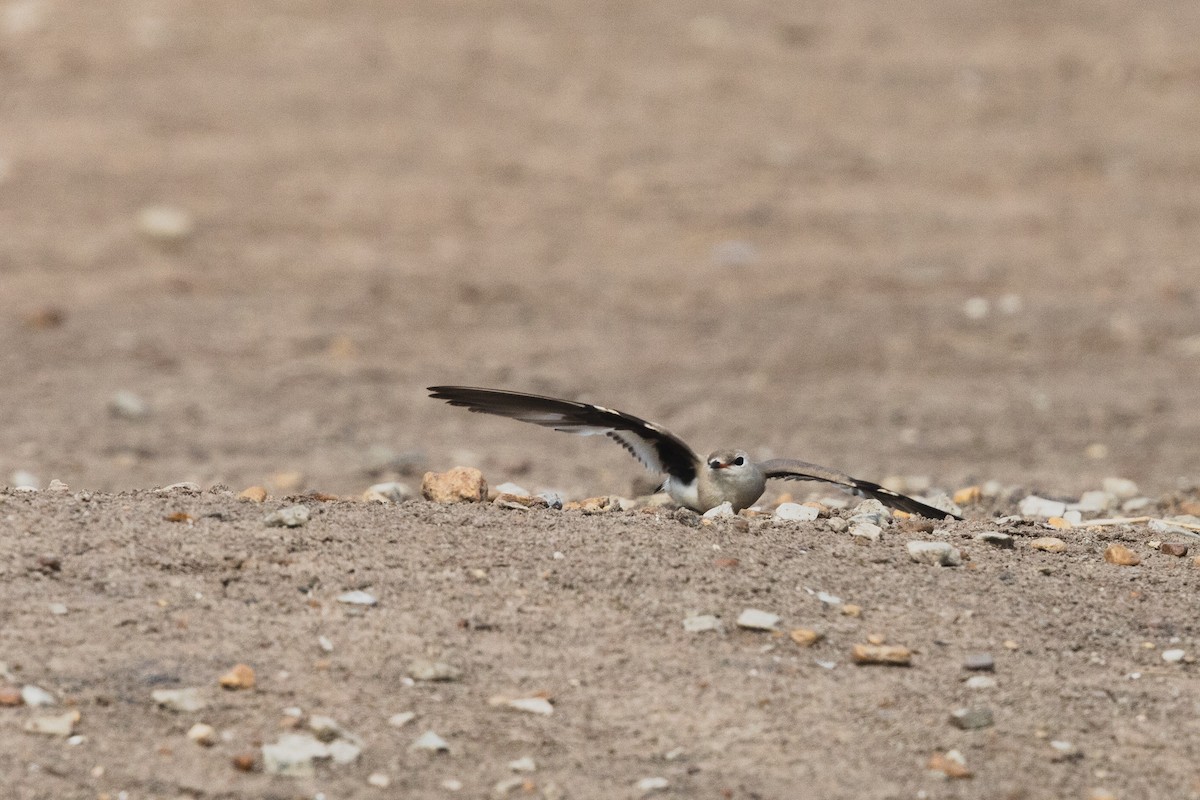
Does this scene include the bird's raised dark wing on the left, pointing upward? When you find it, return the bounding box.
[428,386,700,483]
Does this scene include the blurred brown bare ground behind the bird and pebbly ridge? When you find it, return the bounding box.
[0,0,1200,495]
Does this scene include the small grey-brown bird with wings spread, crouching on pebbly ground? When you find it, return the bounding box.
[427,386,961,519]
